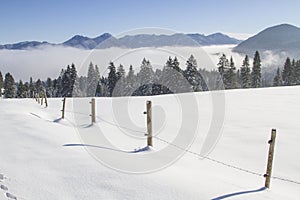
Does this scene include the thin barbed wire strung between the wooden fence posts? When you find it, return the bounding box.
[41,100,300,185]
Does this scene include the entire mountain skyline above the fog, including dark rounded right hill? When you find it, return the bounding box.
[0,24,300,57]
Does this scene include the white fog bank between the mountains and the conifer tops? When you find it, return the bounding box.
[0,45,282,81]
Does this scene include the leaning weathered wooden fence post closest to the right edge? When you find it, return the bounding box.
[264,129,276,188]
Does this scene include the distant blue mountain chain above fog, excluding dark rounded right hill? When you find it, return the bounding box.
[0,33,241,50]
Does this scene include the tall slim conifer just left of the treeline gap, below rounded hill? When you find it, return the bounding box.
[251,51,262,88]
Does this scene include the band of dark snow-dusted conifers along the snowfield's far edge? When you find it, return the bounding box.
[0,51,300,98]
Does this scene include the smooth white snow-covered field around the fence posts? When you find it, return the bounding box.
[0,87,300,200]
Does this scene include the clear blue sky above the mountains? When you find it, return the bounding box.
[0,0,300,44]
